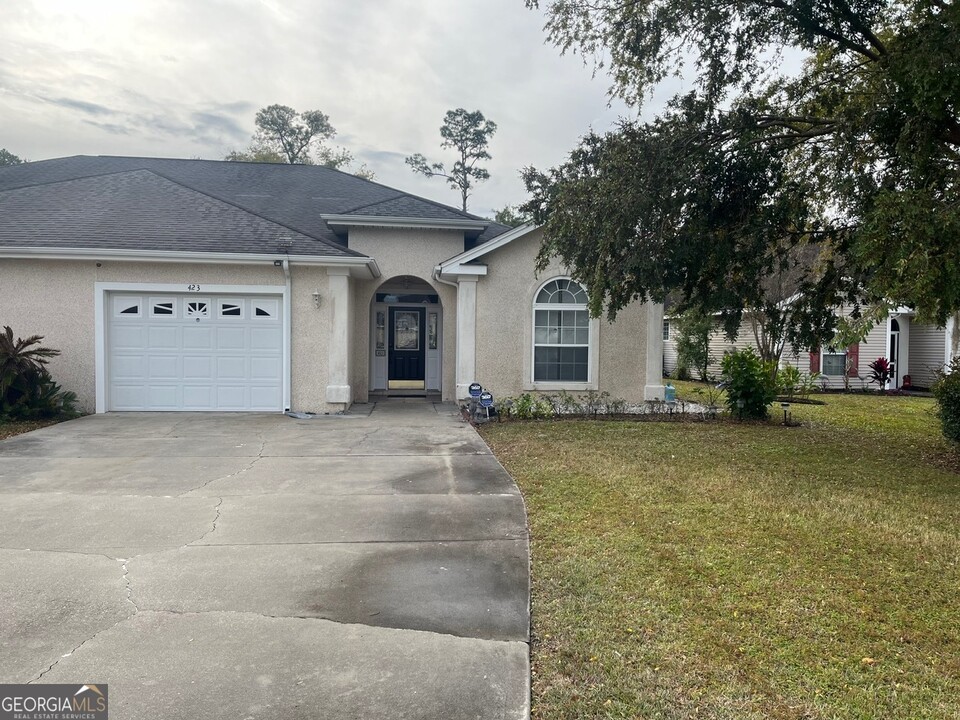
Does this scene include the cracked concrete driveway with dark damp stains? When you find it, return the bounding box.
[0,400,529,720]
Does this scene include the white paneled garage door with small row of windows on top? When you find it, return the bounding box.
[106,293,283,411]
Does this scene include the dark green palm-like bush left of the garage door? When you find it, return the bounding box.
[0,326,79,421]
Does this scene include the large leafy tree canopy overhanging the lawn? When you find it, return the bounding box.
[524,0,960,344]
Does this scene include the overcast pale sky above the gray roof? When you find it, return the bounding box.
[0,0,684,216]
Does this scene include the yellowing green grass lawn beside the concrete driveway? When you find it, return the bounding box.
[483,386,960,720]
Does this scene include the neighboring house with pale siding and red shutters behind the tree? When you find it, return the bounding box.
[662,308,951,389]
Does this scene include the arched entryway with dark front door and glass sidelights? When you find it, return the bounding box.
[370,275,443,395]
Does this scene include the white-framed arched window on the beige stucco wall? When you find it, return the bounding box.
[533,278,590,383]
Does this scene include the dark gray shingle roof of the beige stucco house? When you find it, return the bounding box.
[0,156,509,256]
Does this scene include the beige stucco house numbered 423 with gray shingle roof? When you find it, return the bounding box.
[0,156,663,412]
